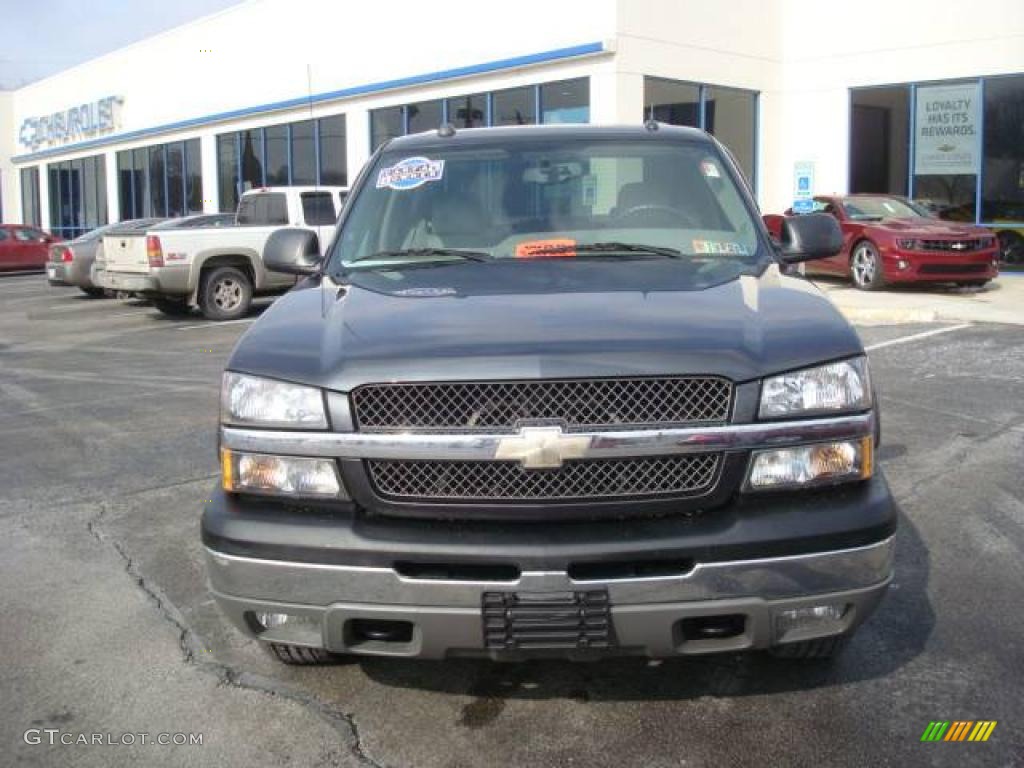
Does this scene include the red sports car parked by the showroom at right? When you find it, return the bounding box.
[765,195,999,291]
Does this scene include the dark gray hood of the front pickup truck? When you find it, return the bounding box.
[228,259,862,391]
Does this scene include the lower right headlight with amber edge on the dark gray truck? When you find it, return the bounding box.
[746,437,873,490]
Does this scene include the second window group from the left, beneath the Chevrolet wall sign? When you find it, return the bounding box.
[46,155,106,240]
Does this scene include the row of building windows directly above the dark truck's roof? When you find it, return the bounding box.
[370,78,590,150]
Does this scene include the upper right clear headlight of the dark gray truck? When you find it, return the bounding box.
[758,357,871,419]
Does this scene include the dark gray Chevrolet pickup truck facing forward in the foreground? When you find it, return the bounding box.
[202,123,896,664]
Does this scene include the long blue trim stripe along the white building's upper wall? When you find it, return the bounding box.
[11,42,605,163]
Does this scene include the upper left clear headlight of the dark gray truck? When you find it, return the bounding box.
[220,371,328,429]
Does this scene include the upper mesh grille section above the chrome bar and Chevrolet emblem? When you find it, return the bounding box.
[352,376,733,432]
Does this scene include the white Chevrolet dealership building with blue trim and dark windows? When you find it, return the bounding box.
[0,0,1024,237]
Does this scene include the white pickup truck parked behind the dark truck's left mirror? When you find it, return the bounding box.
[92,186,348,321]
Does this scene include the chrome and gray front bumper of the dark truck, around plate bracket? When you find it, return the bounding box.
[207,537,894,658]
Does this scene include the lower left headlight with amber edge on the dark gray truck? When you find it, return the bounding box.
[220,449,348,499]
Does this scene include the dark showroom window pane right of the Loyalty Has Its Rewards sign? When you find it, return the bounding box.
[981,75,1024,224]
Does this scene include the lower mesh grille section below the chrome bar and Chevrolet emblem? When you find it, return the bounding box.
[367,454,721,503]
